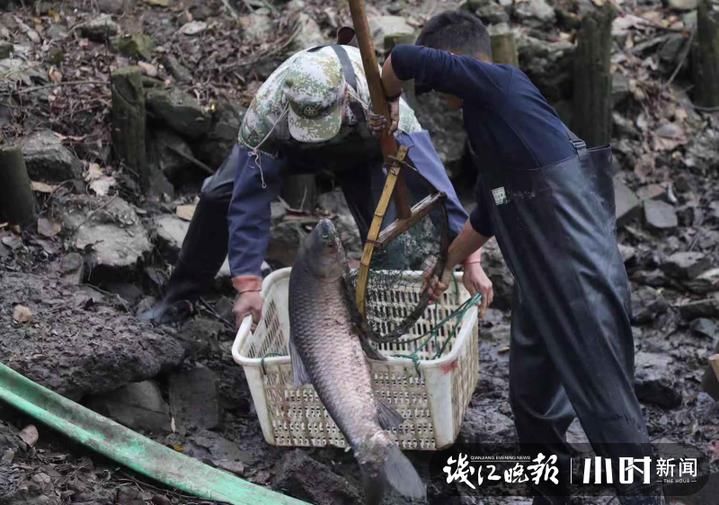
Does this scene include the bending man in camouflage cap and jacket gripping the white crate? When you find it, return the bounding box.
[141,35,491,325]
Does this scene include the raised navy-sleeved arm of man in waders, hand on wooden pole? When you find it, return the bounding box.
[382,44,512,104]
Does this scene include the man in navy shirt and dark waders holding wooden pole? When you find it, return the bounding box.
[382,7,662,505]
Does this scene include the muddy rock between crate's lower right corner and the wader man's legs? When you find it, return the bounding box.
[458,400,516,444]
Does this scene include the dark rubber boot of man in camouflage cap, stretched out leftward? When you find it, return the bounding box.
[138,190,232,324]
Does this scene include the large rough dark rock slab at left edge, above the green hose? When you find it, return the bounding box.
[0,269,184,400]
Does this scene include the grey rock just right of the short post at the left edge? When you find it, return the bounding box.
[19,130,82,182]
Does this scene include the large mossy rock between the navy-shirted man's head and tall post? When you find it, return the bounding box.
[516,32,574,102]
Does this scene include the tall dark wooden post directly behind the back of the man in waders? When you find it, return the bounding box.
[573,2,616,146]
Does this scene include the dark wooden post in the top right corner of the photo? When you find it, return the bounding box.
[692,0,719,107]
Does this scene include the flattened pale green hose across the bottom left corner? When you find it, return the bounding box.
[0,363,309,505]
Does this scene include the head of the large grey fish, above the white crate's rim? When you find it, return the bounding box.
[304,218,347,279]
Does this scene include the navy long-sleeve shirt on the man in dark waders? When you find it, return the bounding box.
[392,44,575,237]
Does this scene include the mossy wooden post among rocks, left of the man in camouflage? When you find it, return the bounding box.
[111,67,150,190]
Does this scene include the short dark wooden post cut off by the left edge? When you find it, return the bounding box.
[0,146,37,227]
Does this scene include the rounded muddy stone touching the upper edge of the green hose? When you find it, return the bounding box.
[88,381,171,433]
